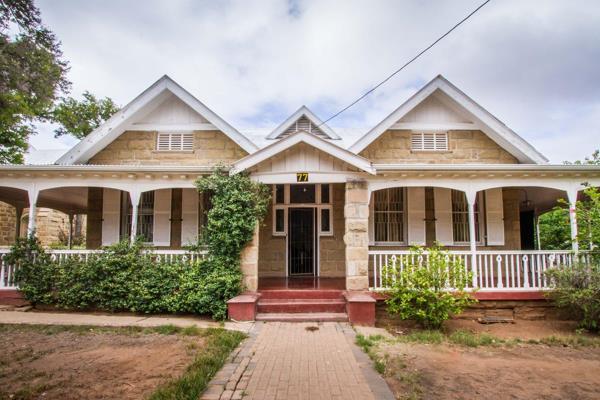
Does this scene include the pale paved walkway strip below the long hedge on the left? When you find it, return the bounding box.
[0,311,254,333]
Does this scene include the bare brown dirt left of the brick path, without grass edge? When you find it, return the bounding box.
[0,329,203,399]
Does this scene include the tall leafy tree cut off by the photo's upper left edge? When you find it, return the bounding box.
[0,0,70,163]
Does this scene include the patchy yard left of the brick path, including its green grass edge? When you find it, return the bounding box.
[0,325,245,400]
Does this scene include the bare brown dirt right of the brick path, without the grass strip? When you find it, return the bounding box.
[376,320,600,400]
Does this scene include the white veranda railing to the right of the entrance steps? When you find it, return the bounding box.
[369,250,591,291]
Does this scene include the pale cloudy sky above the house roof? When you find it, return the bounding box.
[32,0,600,162]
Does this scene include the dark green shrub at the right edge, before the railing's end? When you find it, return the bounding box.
[546,261,600,332]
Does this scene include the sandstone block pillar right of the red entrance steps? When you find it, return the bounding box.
[344,181,369,290]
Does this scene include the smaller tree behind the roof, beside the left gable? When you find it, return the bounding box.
[52,91,119,139]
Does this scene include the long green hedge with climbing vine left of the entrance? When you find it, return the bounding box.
[7,169,270,319]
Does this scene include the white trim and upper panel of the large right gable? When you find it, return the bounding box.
[349,75,548,164]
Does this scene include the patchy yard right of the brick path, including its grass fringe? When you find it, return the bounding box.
[356,322,600,400]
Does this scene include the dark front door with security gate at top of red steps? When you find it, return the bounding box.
[288,208,316,276]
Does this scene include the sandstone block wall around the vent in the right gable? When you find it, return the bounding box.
[360,130,519,164]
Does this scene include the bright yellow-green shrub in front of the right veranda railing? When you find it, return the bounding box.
[384,245,475,329]
